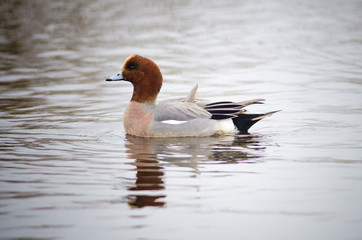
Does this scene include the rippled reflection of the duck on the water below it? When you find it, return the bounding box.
[125,135,265,208]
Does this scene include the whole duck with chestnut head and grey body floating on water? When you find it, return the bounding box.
[106,54,278,137]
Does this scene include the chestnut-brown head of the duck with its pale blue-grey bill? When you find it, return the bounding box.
[106,54,162,103]
